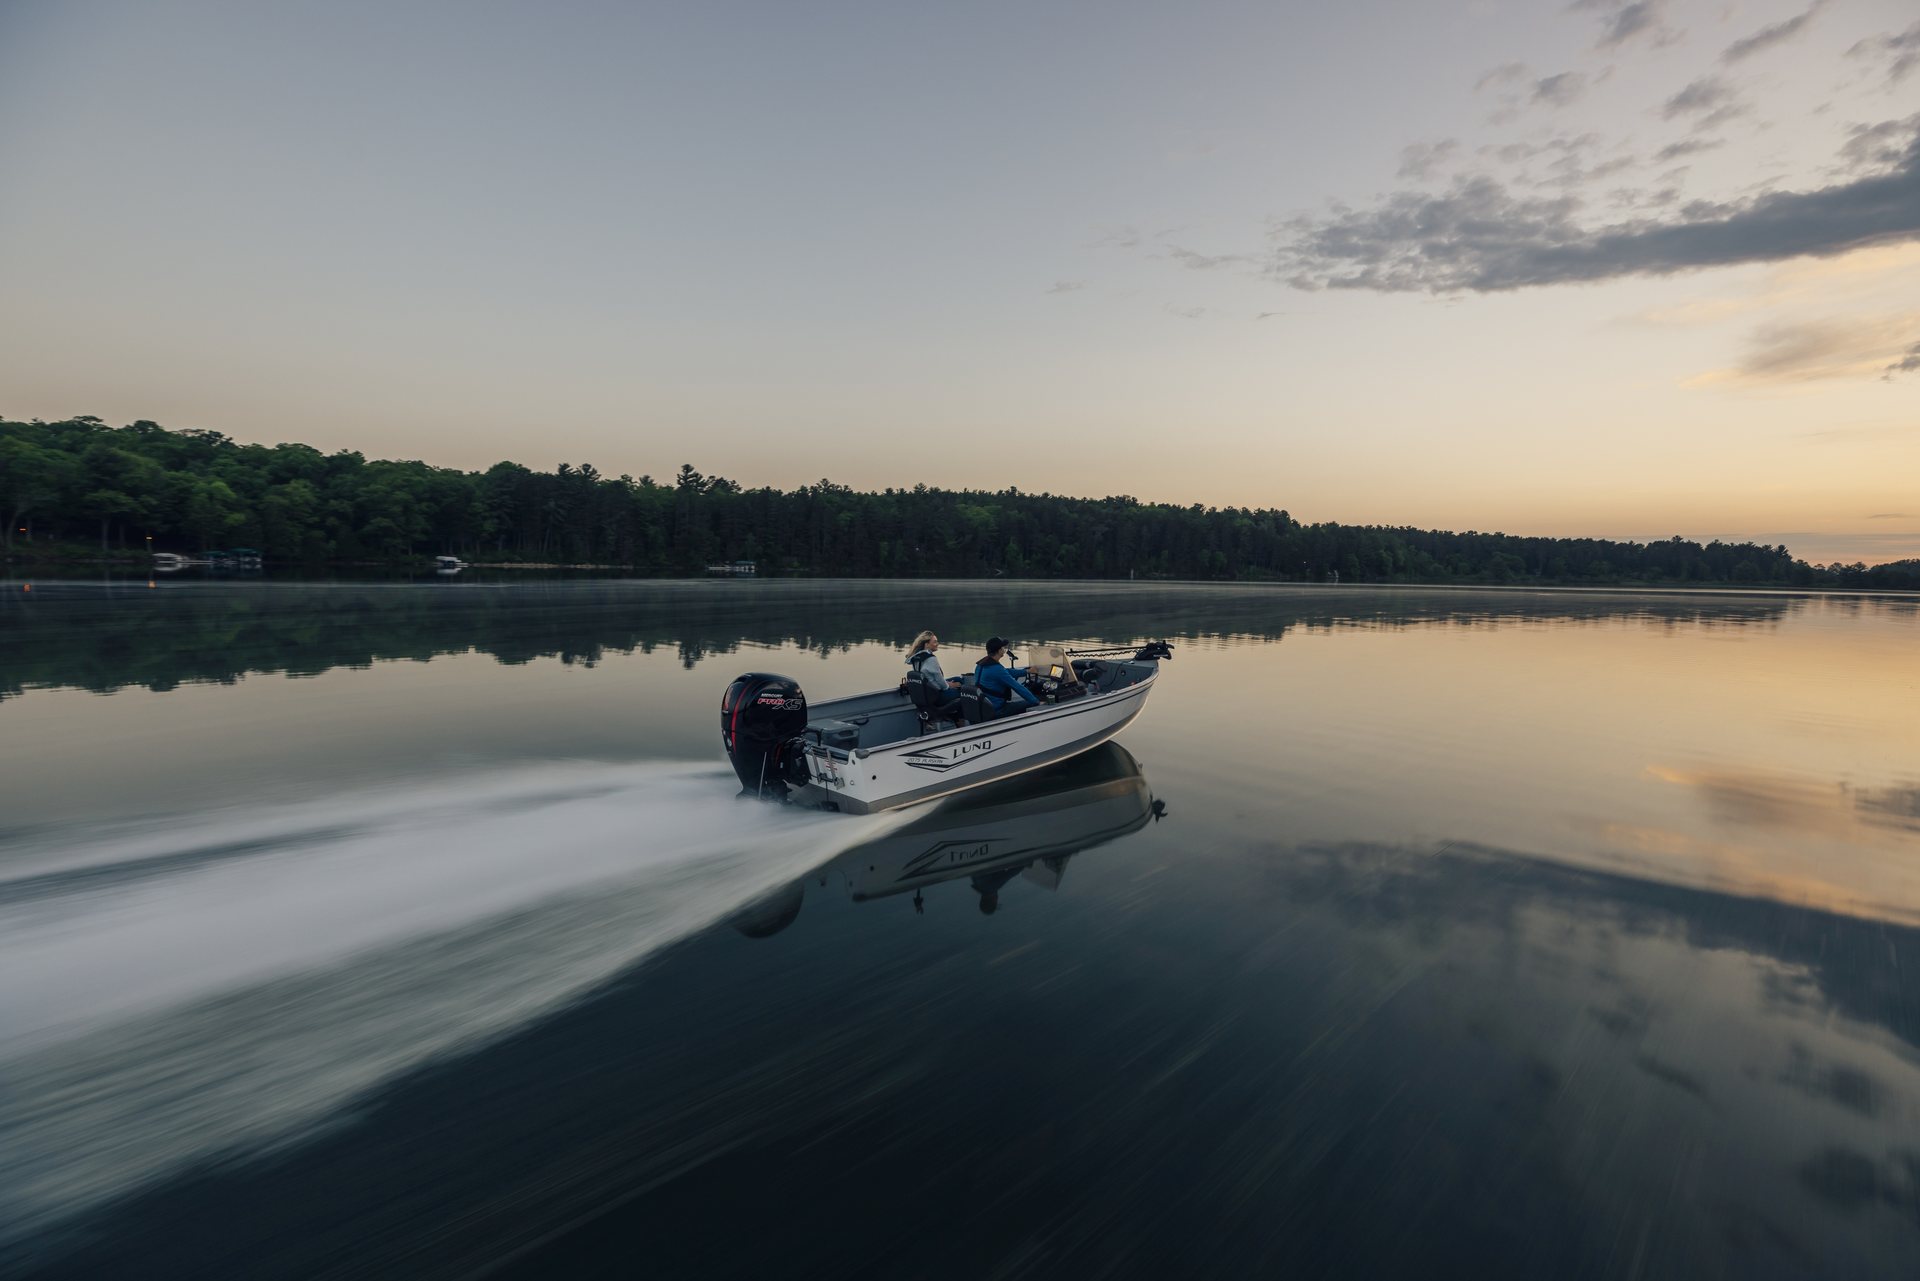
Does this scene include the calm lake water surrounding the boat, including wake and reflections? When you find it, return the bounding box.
[0,576,1920,1279]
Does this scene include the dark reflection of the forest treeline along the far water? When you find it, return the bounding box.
[0,580,1805,697]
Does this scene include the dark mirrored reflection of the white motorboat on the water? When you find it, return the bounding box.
[733,743,1167,939]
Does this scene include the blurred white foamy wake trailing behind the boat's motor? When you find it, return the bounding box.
[0,764,895,1241]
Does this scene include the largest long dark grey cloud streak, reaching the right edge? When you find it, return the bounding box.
[1267,117,1920,294]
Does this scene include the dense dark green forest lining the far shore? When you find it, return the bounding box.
[0,417,1920,588]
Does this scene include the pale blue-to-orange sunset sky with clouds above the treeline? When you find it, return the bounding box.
[0,0,1920,563]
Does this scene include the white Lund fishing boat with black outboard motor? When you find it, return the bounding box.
[720,641,1173,814]
